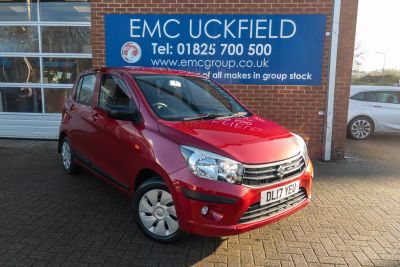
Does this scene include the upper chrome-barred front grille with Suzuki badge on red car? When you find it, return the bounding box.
[242,154,306,187]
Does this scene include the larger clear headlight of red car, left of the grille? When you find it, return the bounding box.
[180,146,243,184]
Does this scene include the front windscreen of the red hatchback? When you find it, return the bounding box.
[133,74,251,121]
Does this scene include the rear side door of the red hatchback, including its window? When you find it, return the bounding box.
[67,73,96,163]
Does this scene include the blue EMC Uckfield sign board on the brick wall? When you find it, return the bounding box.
[104,14,326,85]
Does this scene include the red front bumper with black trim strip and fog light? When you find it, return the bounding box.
[170,161,313,236]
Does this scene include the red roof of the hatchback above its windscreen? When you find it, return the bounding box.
[93,66,203,77]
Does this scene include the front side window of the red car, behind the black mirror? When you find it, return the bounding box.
[99,74,134,109]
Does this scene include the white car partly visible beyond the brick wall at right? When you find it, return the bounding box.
[347,86,400,140]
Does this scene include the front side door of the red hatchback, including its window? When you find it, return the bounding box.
[92,73,140,190]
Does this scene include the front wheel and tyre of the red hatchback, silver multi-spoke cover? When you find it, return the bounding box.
[132,178,184,243]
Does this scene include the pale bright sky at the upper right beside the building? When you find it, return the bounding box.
[356,0,400,71]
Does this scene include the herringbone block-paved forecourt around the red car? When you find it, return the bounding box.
[0,136,400,266]
